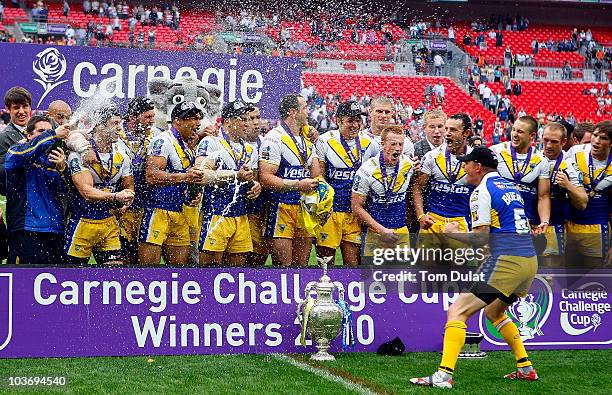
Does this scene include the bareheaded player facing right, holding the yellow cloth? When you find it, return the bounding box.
[259,94,320,266]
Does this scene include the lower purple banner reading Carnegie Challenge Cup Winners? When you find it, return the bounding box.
[0,268,612,358]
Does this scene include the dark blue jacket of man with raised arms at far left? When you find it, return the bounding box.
[4,130,66,234]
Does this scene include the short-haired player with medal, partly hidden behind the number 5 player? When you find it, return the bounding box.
[491,115,550,234]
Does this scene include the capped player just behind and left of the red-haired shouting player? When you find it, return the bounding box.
[316,101,380,266]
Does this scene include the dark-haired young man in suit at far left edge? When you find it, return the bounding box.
[0,86,32,196]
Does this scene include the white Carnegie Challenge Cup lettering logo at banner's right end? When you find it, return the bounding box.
[559,282,611,336]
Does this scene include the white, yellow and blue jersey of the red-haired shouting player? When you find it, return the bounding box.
[353,154,414,229]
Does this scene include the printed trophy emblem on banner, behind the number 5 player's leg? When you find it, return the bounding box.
[480,276,553,345]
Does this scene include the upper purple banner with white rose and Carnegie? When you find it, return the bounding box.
[0,43,301,118]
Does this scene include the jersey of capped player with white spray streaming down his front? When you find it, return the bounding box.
[196,136,258,217]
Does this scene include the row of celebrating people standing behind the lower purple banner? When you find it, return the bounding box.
[2,83,612,266]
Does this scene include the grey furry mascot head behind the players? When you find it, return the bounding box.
[148,77,221,130]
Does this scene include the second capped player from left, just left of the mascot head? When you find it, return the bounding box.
[117,97,155,265]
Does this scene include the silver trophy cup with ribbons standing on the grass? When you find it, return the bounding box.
[297,256,350,361]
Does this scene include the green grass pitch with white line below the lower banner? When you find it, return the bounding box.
[0,350,612,395]
